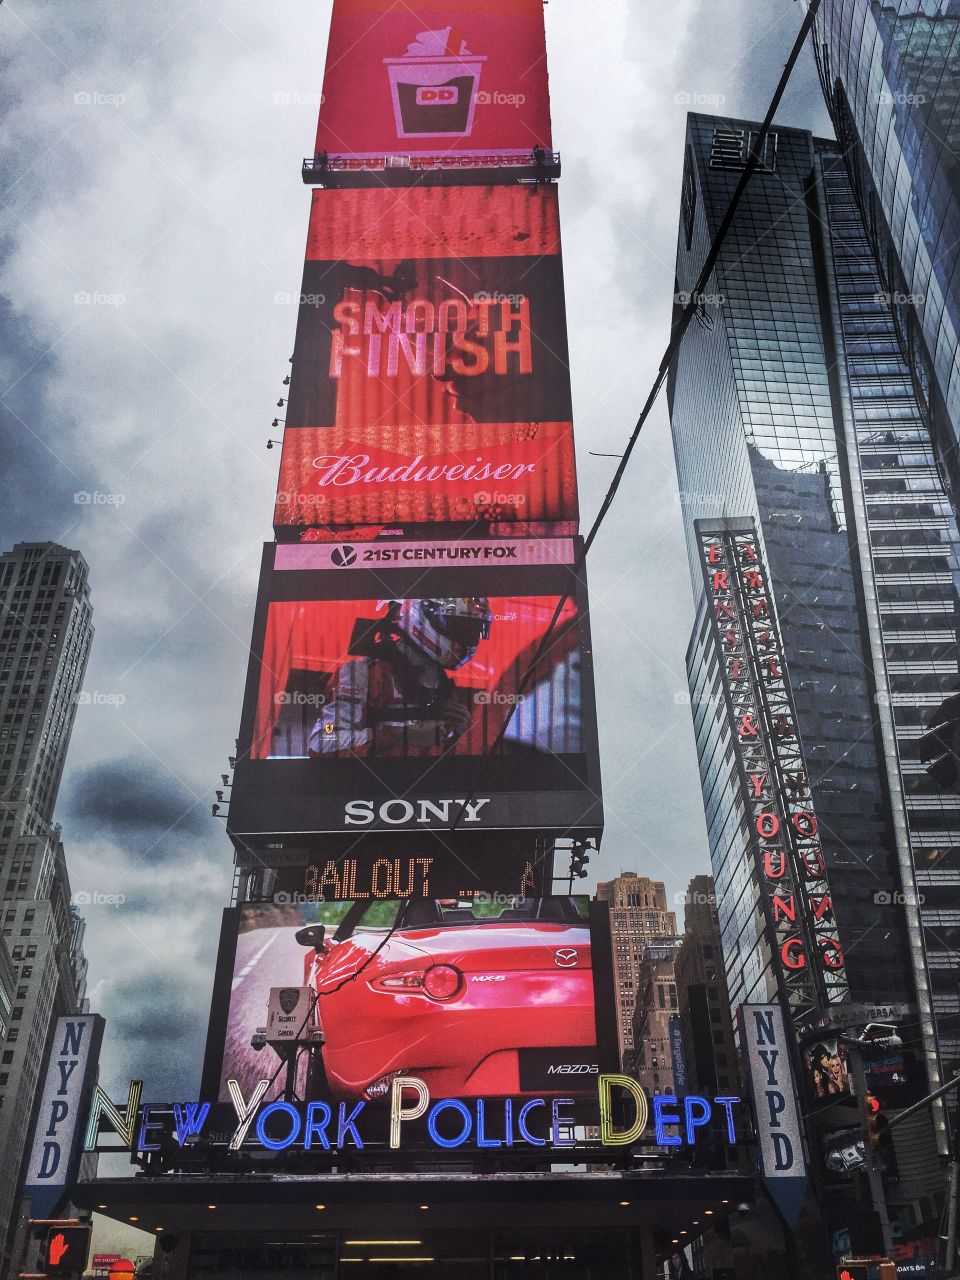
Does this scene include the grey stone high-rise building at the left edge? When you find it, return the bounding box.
[0,543,93,1270]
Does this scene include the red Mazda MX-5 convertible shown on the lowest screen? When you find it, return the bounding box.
[297,897,596,1098]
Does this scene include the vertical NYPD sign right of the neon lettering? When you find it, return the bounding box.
[739,1005,806,1226]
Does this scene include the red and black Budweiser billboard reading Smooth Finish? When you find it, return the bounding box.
[275,186,577,540]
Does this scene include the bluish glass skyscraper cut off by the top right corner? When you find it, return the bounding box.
[813,0,960,509]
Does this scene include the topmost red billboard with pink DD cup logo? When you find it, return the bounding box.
[316,0,550,168]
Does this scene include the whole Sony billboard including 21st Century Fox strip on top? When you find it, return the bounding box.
[228,543,602,838]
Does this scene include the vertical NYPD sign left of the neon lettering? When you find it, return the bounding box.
[23,1014,104,1217]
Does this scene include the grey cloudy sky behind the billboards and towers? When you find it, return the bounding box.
[0,0,829,1098]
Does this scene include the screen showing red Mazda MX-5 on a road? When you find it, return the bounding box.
[220,897,598,1101]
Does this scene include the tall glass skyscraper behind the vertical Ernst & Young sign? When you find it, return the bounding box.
[669,115,960,1192]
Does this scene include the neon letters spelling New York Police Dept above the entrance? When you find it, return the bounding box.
[83,1075,741,1153]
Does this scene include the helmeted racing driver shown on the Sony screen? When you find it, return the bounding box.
[307,596,492,756]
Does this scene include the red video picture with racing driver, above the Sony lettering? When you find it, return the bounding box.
[250,595,582,760]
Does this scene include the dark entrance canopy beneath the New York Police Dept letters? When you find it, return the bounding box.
[73,1171,754,1280]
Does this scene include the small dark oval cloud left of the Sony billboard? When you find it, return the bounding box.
[61,759,210,856]
